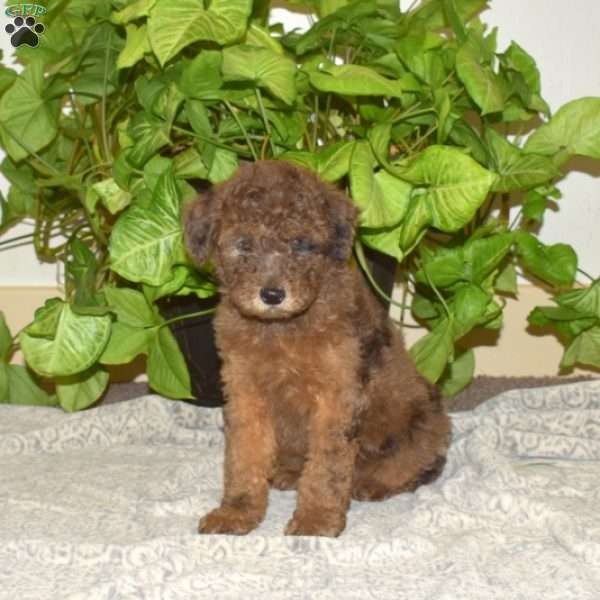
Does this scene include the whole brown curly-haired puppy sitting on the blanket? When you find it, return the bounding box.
[184,161,449,536]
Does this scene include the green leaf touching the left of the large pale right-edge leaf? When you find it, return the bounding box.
[486,128,560,192]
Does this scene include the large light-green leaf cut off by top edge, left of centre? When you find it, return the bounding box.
[148,0,252,66]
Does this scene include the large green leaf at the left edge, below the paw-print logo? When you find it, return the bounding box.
[0,61,60,161]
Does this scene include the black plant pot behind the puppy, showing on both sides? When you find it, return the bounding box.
[158,247,396,407]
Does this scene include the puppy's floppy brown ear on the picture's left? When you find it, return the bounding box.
[183,190,217,266]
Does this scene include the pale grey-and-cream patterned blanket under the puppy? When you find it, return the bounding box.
[0,382,600,600]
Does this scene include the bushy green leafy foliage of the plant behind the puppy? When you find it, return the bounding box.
[0,0,600,410]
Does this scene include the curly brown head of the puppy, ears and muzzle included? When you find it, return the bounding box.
[184,161,357,319]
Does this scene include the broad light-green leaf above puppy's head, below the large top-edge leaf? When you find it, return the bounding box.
[222,46,296,104]
